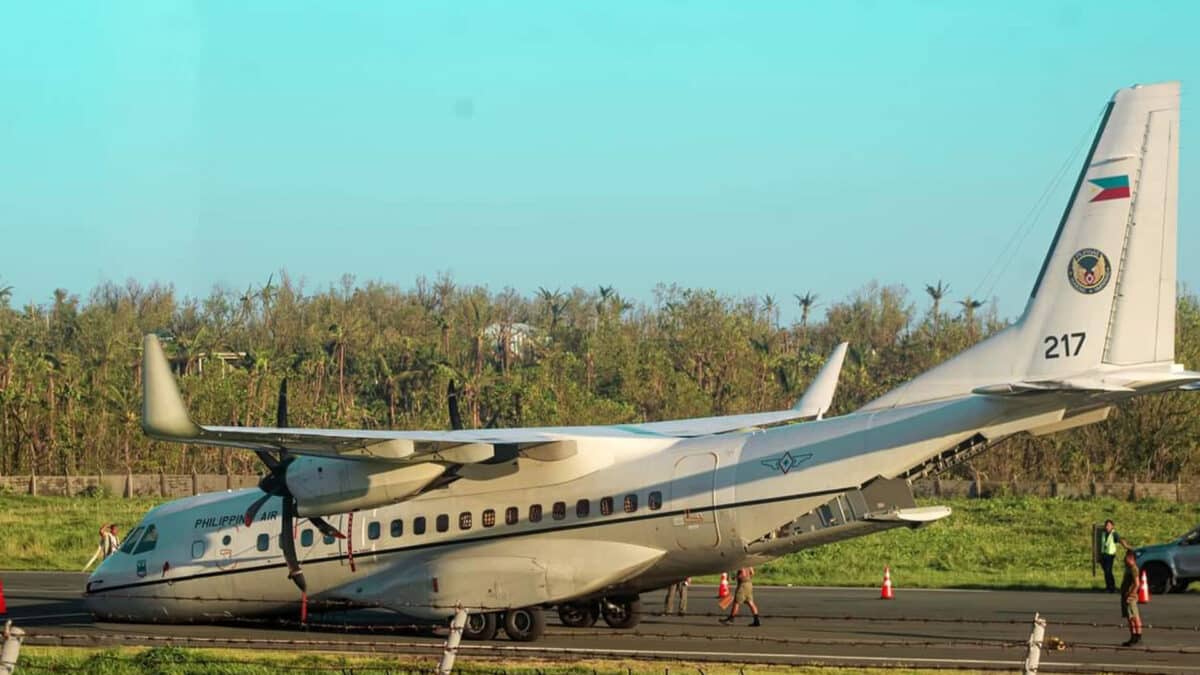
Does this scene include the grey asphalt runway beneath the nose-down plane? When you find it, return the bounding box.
[0,572,1200,673]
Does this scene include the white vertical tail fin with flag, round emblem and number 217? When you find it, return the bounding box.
[868,82,1180,408]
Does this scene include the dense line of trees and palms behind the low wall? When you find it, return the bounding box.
[0,273,1200,482]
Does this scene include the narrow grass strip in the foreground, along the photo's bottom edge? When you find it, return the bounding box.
[18,646,966,675]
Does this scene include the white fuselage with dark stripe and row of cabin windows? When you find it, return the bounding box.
[88,389,1066,621]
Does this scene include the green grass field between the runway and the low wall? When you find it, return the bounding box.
[0,487,1200,589]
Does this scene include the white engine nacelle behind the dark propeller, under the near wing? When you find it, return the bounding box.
[287,456,446,516]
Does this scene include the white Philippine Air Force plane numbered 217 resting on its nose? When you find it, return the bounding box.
[86,83,1200,640]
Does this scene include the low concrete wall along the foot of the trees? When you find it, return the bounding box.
[0,473,1200,503]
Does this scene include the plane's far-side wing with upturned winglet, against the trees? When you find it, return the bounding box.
[618,342,850,437]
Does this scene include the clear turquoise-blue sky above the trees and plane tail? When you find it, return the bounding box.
[0,0,1200,318]
